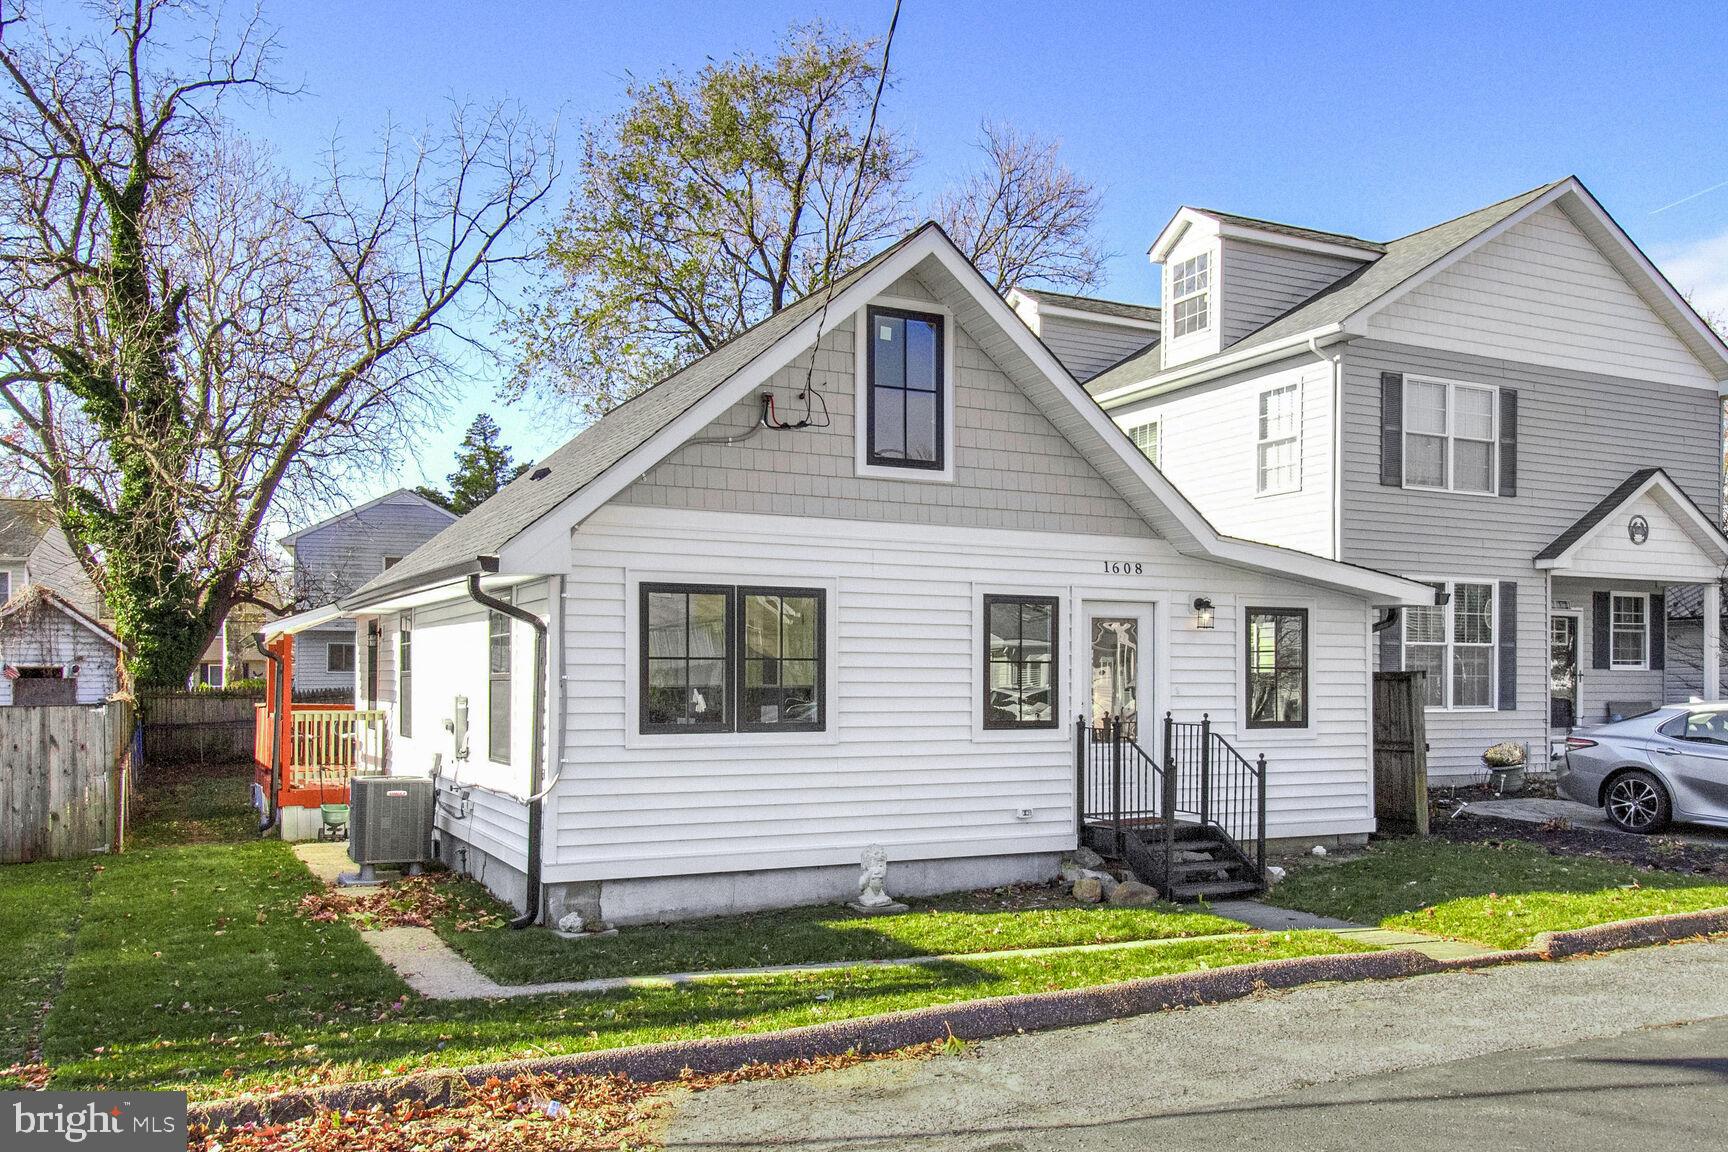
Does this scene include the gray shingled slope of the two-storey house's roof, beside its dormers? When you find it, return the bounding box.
[1087,180,1566,396]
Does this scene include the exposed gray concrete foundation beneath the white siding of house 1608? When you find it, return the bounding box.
[439,831,1061,924]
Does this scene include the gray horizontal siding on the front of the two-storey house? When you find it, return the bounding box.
[1343,342,1721,777]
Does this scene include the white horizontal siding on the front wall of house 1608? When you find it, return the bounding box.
[552,504,1372,883]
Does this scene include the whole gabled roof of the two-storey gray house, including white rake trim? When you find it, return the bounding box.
[1089,176,1728,399]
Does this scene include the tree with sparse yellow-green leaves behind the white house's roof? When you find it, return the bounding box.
[511,26,914,415]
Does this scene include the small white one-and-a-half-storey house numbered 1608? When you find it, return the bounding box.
[307,225,1434,922]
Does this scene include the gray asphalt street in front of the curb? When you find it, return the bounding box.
[664,943,1728,1152]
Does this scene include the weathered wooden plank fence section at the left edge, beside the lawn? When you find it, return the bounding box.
[0,699,138,864]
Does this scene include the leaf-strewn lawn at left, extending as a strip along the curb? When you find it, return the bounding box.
[0,766,1356,1098]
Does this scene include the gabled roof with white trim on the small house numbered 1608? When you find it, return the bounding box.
[342,223,1434,611]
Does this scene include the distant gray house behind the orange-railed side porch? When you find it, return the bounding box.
[280,489,456,698]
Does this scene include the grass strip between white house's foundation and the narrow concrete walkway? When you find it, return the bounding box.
[437,883,1246,984]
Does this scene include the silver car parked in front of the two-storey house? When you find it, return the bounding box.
[1557,703,1728,832]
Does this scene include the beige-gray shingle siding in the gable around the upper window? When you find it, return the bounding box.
[617,276,1153,535]
